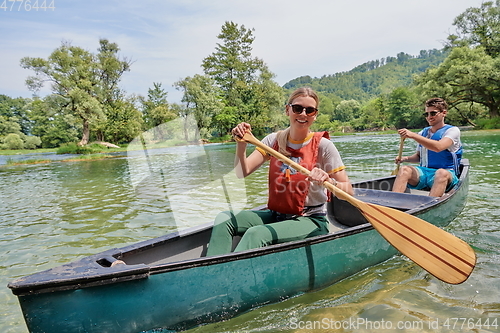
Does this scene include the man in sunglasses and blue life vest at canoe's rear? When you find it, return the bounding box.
[392,98,462,197]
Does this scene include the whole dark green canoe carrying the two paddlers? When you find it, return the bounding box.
[9,159,469,333]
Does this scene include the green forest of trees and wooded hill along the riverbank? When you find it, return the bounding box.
[0,0,500,149]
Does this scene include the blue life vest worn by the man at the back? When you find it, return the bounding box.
[418,125,462,176]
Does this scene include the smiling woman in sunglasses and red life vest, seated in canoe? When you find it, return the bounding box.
[207,88,353,256]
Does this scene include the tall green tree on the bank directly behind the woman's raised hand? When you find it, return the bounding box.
[202,22,284,134]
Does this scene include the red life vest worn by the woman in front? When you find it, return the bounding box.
[267,132,330,215]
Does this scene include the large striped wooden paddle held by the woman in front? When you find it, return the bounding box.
[242,133,476,284]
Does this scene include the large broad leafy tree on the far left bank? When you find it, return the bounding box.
[21,39,130,145]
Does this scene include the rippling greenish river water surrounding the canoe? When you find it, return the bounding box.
[0,131,500,333]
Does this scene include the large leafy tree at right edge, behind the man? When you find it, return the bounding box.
[415,0,500,126]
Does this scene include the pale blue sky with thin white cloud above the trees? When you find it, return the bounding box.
[0,0,481,102]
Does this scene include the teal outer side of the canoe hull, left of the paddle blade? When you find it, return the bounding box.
[19,228,397,333]
